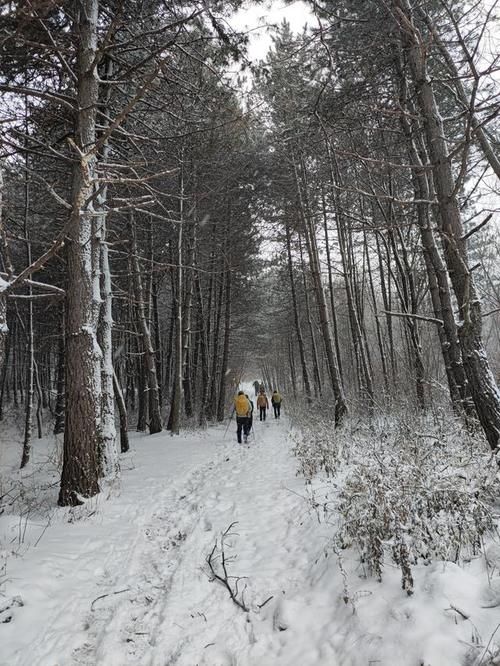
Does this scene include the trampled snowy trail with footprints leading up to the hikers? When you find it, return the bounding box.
[69,419,333,666]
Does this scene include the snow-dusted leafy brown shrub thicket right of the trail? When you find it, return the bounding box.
[295,408,500,594]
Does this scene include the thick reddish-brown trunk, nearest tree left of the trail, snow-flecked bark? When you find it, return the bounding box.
[59,0,102,506]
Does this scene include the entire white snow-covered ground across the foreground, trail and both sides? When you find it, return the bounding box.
[0,408,500,666]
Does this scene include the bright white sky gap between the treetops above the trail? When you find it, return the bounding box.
[229,0,313,61]
